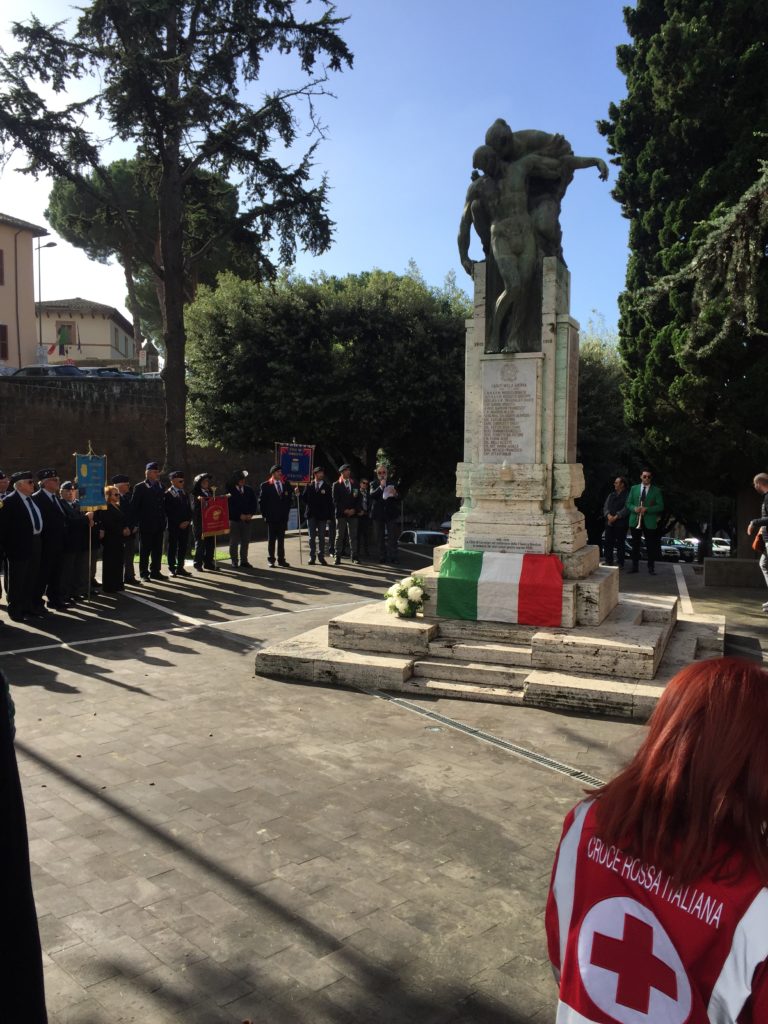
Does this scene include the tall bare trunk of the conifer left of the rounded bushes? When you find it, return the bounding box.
[159,159,186,472]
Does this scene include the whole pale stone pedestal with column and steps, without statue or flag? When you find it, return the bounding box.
[256,257,725,720]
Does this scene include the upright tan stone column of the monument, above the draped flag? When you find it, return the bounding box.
[449,257,618,620]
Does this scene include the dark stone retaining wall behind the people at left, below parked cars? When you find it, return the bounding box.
[0,377,272,485]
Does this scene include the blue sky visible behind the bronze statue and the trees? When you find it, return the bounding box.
[0,0,627,326]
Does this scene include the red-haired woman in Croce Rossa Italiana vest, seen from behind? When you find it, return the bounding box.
[546,657,768,1024]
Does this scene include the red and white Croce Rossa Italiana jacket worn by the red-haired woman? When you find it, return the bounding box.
[546,801,768,1024]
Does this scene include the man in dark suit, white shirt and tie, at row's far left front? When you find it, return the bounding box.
[0,471,47,623]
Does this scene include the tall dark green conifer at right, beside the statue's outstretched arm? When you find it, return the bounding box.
[598,0,768,492]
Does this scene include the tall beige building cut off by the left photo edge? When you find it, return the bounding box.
[0,213,48,370]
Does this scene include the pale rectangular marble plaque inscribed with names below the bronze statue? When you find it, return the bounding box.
[480,358,540,463]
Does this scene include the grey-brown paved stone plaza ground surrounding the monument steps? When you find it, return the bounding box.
[0,541,768,1024]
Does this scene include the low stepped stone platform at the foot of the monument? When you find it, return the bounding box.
[256,596,725,721]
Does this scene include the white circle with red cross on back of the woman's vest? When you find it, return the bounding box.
[579,896,691,1024]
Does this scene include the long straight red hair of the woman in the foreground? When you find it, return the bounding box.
[596,657,768,884]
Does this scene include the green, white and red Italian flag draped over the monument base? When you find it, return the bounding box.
[436,548,562,626]
